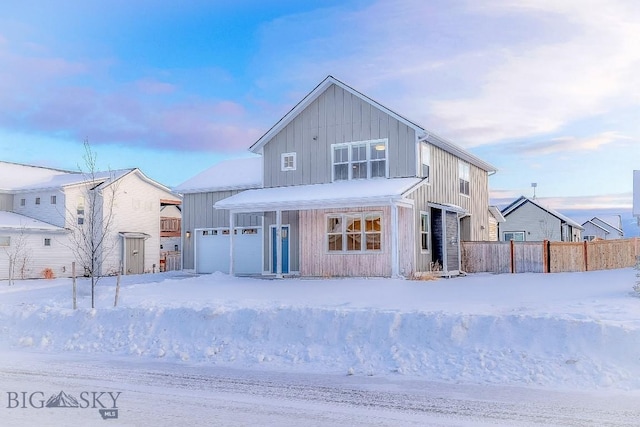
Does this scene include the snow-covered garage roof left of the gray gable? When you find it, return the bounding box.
[173,156,262,194]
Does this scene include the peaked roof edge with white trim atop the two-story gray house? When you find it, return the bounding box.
[249,76,497,172]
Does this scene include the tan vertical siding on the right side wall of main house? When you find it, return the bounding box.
[408,144,489,272]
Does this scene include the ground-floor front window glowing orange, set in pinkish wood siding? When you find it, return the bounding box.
[327,212,382,253]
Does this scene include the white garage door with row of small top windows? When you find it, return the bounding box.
[195,228,262,274]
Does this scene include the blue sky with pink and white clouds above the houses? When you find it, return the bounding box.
[0,0,640,217]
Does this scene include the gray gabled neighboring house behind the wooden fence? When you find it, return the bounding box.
[499,196,583,242]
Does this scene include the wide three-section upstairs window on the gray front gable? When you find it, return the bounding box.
[331,139,388,181]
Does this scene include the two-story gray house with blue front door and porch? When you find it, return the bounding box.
[174,76,496,277]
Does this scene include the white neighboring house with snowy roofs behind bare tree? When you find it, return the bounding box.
[0,162,181,279]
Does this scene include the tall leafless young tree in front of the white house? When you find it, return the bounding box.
[67,140,118,308]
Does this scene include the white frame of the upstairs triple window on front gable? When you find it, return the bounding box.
[331,138,389,182]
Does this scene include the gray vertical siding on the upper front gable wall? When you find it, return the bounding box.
[263,84,418,187]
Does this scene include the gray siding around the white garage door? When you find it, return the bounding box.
[182,190,262,269]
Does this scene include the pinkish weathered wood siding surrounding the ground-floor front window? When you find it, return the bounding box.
[300,206,396,277]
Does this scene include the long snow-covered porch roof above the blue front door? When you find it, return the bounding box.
[214,178,422,212]
